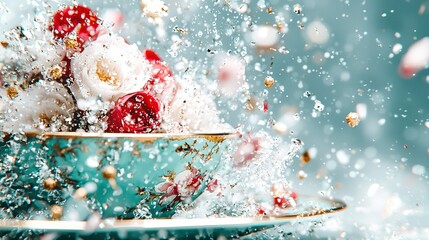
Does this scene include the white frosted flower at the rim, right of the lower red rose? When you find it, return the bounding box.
[162,80,229,133]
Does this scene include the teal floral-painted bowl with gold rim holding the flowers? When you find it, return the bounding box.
[0,133,236,220]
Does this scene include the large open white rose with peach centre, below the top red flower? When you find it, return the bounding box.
[71,34,150,102]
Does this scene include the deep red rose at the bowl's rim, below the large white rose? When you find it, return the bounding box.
[106,91,161,133]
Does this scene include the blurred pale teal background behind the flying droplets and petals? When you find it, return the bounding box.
[0,0,429,238]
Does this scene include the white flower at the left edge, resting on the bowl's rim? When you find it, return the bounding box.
[2,81,74,132]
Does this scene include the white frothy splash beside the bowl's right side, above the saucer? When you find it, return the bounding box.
[174,131,304,218]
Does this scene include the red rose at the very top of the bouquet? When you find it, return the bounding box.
[50,5,99,45]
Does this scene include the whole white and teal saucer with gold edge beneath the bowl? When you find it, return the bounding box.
[0,196,346,239]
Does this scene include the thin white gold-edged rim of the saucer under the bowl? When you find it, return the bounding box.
[0,197,347,232]
